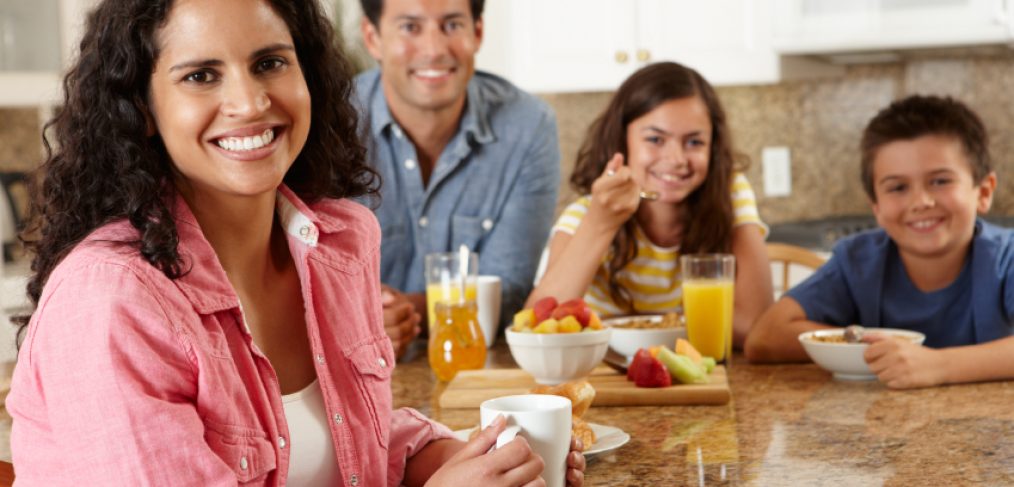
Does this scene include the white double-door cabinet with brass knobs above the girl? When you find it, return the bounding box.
[477,0,779,92]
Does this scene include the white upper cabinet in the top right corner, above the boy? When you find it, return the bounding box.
[773,0,1014,54]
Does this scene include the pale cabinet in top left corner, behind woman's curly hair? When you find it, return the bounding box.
[0,0,96,107]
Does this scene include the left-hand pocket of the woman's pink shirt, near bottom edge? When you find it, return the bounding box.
[204,419,278,485]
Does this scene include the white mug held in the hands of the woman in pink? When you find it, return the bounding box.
[479,394,571,487]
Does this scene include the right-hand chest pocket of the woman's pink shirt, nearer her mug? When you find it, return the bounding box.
[349,335,394,450]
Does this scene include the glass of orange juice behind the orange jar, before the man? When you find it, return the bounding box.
[426,252,479,332]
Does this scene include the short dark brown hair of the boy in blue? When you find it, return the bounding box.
[860,94,993,202]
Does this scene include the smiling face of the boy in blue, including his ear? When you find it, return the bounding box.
[873,135,996,262]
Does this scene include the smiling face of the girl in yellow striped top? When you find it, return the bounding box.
[627,96,712,203]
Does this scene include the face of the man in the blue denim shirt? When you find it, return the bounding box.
[362,0,483,116]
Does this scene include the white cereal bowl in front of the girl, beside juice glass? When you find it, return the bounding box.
[602,312,686,358]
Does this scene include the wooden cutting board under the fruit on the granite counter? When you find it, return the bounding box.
[440,365,731,409]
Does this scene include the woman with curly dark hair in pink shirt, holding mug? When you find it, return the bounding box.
[6,0,583,486]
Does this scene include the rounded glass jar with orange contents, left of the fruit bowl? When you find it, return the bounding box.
[428,299,486,382]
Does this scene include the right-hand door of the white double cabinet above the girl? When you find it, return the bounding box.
[636,0,779,85]
